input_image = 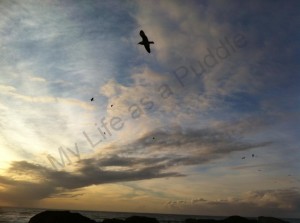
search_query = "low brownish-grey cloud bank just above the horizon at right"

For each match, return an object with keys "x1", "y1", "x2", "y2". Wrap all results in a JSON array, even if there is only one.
[{"x1": 165, "y1": 188, "x2": 300, "y2": 217}]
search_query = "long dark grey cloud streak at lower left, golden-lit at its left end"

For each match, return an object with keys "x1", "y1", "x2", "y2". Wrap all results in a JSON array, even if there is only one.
[{"x1": 0, "y1": 160, "x2": 181, "y2": 205}]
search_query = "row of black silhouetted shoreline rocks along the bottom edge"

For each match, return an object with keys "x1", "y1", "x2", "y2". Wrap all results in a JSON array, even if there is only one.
[{"x1": 28, "y1": 211, "x2": 288, "y2": 223}]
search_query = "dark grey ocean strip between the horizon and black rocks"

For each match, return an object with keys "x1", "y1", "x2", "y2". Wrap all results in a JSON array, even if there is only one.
[{"x1": 0, "y1": 207, "x2": 300, "y2": 223}]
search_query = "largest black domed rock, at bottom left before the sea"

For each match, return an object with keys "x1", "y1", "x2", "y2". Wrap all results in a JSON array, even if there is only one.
[{"x1": 29, "y1": 211, "x2": 96, "y2": 223}]
